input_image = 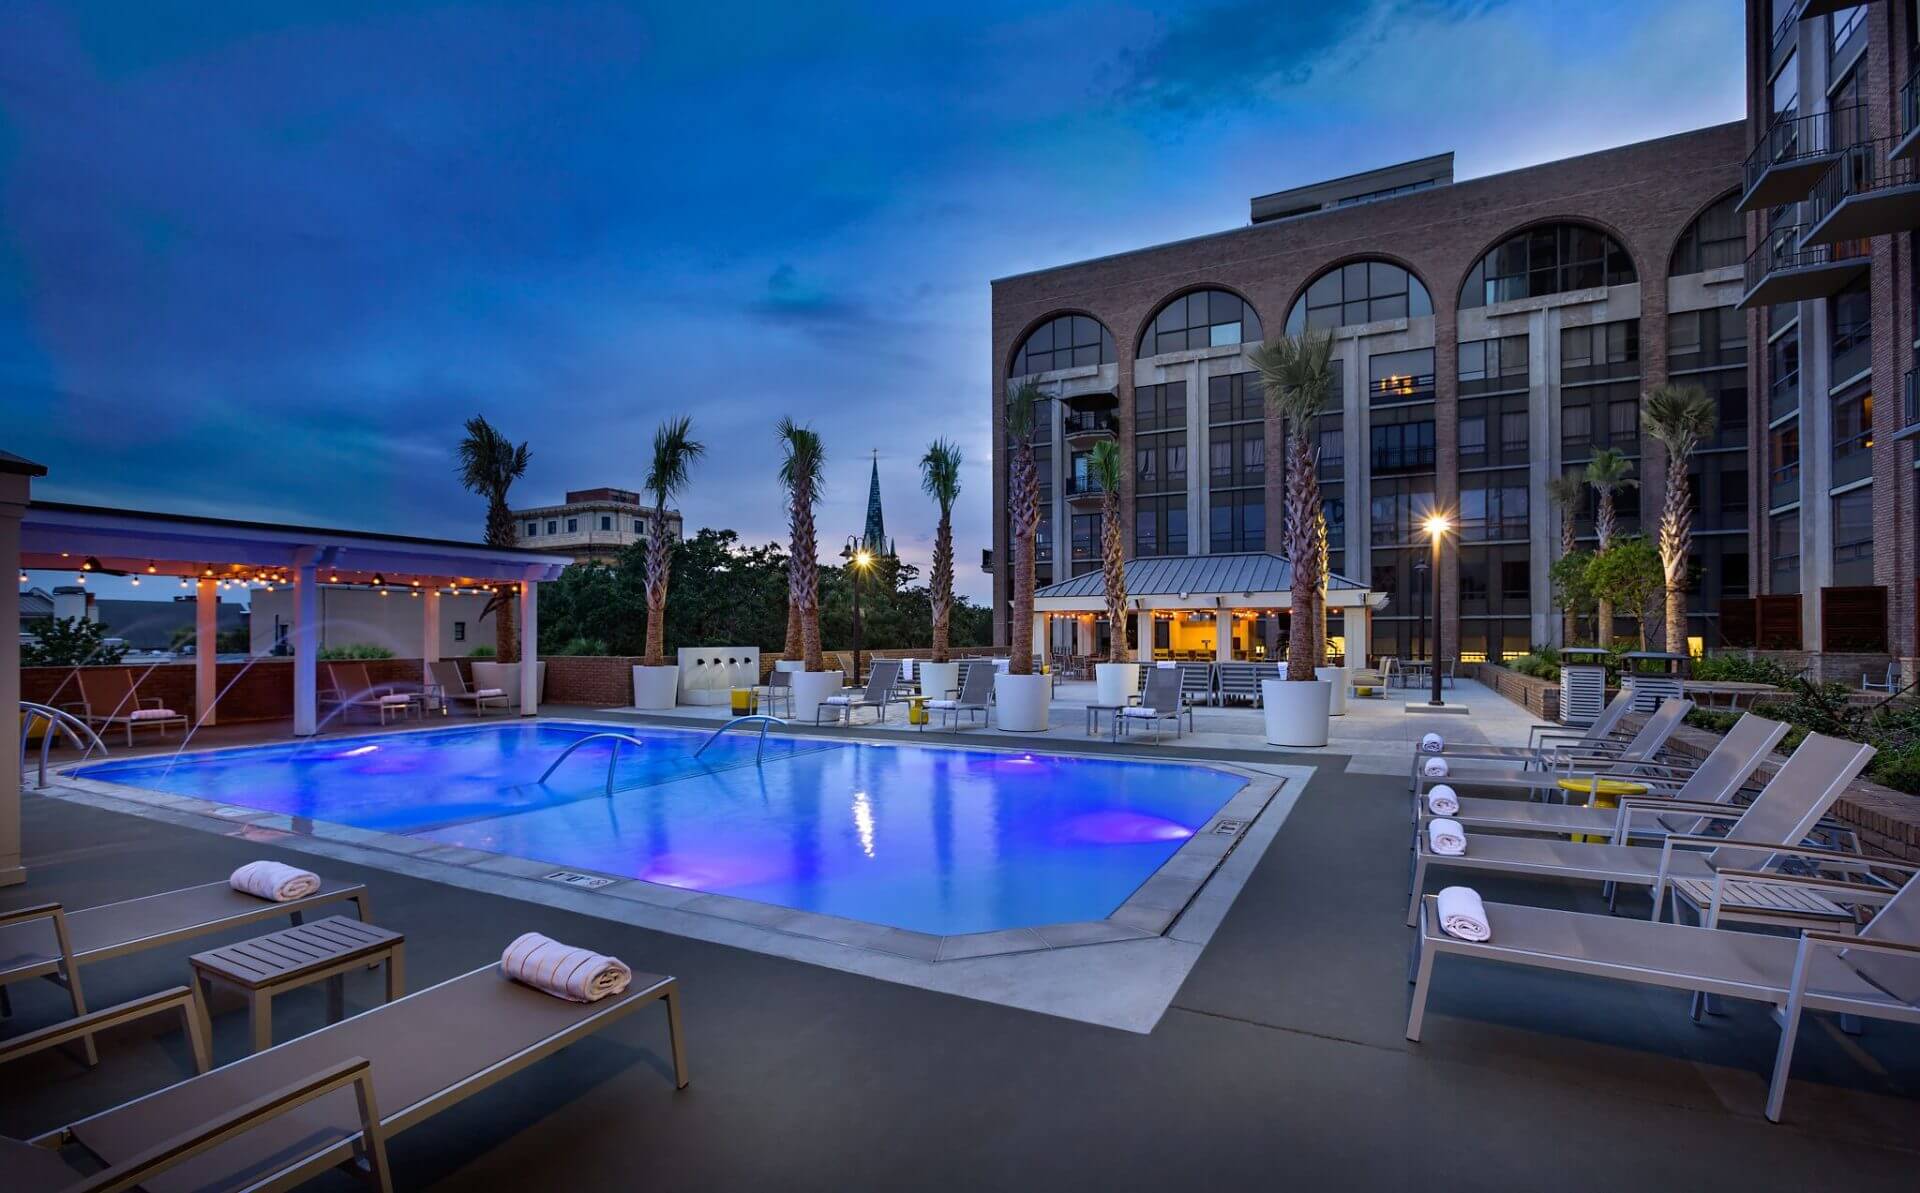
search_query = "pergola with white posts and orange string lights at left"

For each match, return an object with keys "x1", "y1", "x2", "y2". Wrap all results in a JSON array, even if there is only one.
[{"x1": 0, "y1": 451, "x2": 572, "y2": 886}]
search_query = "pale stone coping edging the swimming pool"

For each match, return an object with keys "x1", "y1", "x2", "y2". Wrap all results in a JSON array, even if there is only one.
[{"x1": 60, "y1": 717, "x2": 1288, "y2": 962}]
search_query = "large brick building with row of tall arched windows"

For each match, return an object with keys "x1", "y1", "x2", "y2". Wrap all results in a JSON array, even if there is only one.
[{"x1": 989, "y1": 123, "x2": 1755, "y2": 661}]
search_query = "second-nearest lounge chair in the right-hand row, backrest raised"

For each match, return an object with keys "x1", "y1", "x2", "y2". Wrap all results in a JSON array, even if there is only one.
[{"x1": 1407, "y1": 734, "x2": 1874, "y2": 928}]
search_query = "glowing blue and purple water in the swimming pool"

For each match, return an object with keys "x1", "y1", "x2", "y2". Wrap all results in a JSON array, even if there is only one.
[{"x1": 79, "y1": 720, "x2": 1244, "y2": 936}]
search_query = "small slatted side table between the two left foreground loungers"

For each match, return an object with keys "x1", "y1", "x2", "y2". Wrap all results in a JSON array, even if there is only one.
[{"x1": 188, "y1": 916, "x2": 407, "y2": 1053}]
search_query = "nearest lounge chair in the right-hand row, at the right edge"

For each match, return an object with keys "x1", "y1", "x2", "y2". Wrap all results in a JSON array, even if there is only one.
[{"x1": 1407, "y1": 866, "x2": 1920, "y2": 1122}]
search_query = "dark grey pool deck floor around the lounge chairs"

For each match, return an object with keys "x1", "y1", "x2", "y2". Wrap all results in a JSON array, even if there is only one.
[{"x1": 11, "y1": 684, "x2": 1920, "y2": 1191}]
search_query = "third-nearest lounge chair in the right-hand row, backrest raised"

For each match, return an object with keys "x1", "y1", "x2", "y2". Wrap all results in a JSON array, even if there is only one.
[{"x1": 1413, "y1": 713, "x2": 1788, "y2": 843}]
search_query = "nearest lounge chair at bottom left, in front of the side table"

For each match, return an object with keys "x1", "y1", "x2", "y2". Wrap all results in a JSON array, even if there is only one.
[{"x1": 11, "y1": 964, "x2": 687, "y2": 1193}]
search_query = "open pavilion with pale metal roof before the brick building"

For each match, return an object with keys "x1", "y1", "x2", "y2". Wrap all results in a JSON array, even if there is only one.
[{"x1": 1033, "y1": 551, "x2": 1386, "y2": 663}]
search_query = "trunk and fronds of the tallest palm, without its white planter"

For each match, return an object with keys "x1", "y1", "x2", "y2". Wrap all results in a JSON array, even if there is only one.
[{"x1": 1248, "y1": 332, "x2": 1332, "y2": 680}]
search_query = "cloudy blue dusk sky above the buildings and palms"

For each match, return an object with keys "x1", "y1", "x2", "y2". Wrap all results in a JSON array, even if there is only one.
[{"x1": 0, "y1": 0, "x2": 1741, "y2": 596}]
